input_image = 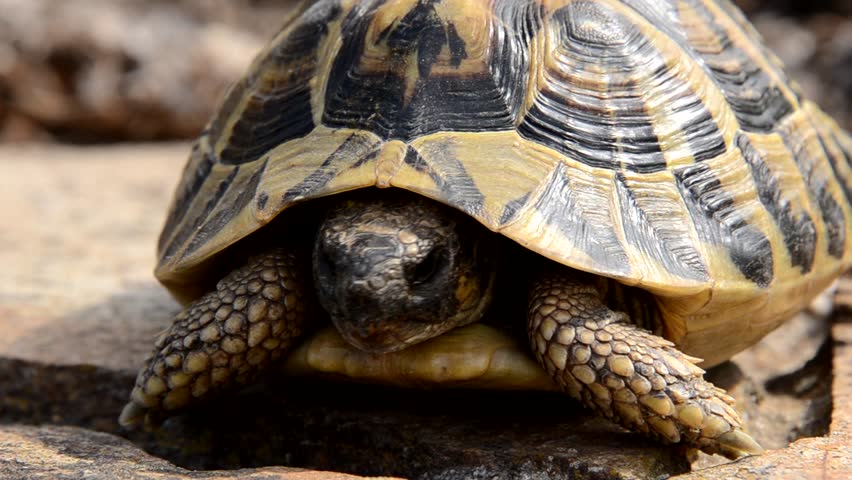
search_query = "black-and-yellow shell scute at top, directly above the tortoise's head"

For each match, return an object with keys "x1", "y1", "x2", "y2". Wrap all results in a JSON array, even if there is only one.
[{"x1": 322, "y1": 1, "x2": 528, "y2": 141}]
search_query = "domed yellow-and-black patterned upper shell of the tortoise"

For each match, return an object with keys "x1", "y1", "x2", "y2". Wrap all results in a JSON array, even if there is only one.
[{"x1": 156, "y1": 0, "x2": 852, "y2": 365}]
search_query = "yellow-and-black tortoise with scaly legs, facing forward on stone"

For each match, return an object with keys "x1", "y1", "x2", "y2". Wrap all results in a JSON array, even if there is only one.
[{"x1": 120, "y1": 0, "x2": 852, "y2": 458}]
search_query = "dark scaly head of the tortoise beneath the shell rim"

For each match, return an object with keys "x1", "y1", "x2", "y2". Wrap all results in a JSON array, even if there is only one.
[{"x1": 313, "y1": 192, "x2": 495, "y2": 353}]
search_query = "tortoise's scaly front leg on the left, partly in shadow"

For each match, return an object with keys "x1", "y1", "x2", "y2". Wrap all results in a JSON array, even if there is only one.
[{"x1": 119, "y1": 249, "x2": 310, "y2": 426}]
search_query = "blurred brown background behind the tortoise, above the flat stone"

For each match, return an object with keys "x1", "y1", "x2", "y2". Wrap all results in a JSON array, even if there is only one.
[{"x1": 0, "y1": 0, "x2": 852, "y2": 144}]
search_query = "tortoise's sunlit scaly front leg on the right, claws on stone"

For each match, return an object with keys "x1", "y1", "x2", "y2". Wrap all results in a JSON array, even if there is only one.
[{"x1": 528, "y1": 272, "x2": 763, "y2": 458}]
